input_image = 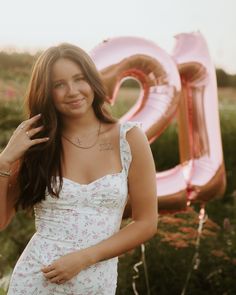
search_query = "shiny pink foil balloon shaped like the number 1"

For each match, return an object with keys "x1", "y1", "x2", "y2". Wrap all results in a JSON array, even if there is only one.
[{"x1": 173, "y1": 32, "x2": 226, "y2": 201}]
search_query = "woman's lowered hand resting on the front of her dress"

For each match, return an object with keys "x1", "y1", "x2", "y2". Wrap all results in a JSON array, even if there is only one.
[{"x1": 41, "y1": 252, "x2": 86, "y2": 284}]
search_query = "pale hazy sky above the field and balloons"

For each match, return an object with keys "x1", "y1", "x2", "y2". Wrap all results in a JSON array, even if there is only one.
[{"x1": 0, "y1": 0, "x2": 236, "y2": 74}]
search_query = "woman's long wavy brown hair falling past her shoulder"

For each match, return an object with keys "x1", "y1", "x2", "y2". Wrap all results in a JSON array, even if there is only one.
[{"x1": 16, "y1": 43, "x2": 116, "y2": 211}]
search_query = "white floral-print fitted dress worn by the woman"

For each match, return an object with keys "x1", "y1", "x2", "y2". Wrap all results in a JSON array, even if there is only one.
[{"x1": 7, "y1": 122, "x2": 140, "y2": 295}]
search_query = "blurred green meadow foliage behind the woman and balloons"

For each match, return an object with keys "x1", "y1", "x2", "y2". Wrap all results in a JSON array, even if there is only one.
[{"x1": 0, "y1": 52, "x2": 236, "y2": 295}]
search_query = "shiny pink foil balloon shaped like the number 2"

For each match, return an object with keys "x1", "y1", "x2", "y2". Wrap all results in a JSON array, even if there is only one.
[{"x1": 91, "y1": 37, "x2": 187, "y2": 211}]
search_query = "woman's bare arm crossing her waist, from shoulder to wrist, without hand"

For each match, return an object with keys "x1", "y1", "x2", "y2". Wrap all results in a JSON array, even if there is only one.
[{"x1": 81, "y1": 128, "x2": 158, "y2": 263}]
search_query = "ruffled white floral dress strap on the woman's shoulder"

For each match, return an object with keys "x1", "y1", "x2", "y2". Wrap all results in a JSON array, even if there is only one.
[{"x1": 120, "y1": 121, "x2": 142, "y2": 175}]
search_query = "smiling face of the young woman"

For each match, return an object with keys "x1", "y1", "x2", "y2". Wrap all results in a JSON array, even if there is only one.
[{"x1": 51, "y1": 58, "x2": 94, "y2": 117}]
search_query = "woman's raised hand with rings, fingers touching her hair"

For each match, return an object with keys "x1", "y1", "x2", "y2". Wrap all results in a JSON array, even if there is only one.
[{"x1": 1, "y1": 114, "x2": 49, "y2": 165}]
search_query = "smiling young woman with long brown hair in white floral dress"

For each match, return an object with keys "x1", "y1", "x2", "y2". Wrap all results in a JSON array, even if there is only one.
[{"x1": 0, "y1": 44, "x2": 157, "y2": 295}]
